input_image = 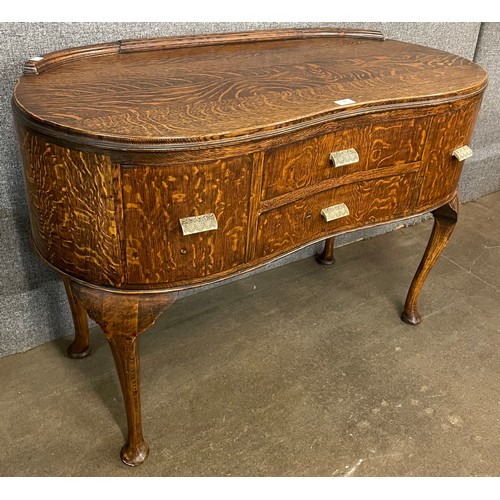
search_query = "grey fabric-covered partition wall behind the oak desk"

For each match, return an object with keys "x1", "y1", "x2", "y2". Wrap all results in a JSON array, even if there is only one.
[{"x1": 0, "y1": 23, "x2": 500, "y2": 356}]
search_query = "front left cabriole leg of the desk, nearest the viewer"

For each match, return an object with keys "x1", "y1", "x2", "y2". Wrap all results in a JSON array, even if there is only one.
[{"x1": 71, "y1": 282, "x2": 176, "y2": 466}]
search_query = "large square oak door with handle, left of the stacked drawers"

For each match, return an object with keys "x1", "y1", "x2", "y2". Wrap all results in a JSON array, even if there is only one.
[{"x1": 122, "y1": 156, "x2": 252, "y2": 284}]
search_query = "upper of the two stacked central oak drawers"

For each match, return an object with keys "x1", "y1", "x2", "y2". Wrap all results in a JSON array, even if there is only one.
[{"x1": 262, "y1": 117, "x2": 428, "y2": 200}]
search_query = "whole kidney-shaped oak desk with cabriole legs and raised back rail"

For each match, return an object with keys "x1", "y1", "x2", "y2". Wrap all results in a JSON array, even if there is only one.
[{"x1": 13, "y1": 29, "x2": 487, "y2": 465}]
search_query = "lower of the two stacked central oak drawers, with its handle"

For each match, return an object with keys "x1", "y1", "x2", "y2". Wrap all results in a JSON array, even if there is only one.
[{"x1": 256, "y1": 172, "x2": 417, "y2": 258}]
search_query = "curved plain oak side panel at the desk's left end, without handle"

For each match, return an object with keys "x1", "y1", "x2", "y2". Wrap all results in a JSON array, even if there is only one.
[{"x1": 19, "y1": 130, "x2": 123, "y2": 286}]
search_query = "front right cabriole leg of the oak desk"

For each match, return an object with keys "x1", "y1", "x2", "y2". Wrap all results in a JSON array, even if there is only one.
[{"x1": 401, "y1": 196, "x2": 458, "y2": 325}]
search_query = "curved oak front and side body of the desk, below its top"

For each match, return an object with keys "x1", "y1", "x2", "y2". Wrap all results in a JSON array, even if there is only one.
[{"x1": 18, "y1": 93, "x2": 481, "y2": 290}]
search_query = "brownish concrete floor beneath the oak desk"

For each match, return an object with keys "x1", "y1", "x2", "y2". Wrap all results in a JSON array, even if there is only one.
[{"x1": 0, "y1": 192, "x2": 500, "y2": 476}]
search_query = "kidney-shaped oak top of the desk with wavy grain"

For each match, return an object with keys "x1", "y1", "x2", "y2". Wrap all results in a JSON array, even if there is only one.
[{"x1": 14, "y1": 30, "x2": 486, "y2": 147}]
